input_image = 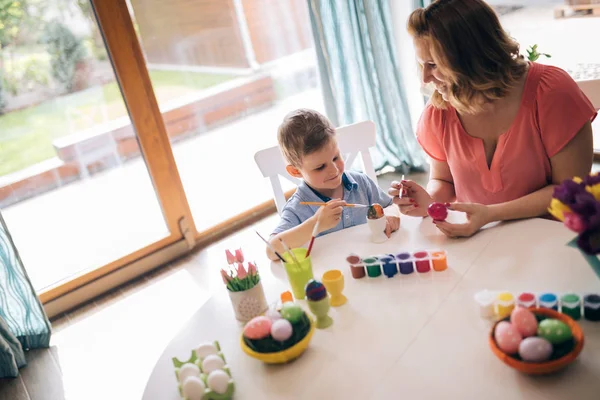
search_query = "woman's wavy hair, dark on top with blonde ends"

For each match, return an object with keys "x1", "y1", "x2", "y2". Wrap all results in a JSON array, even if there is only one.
[{"x1": 407, "y1": 0, "x2": 527, "y2": 113}]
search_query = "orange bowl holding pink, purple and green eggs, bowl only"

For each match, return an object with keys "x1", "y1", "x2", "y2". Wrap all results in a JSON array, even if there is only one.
[{"x1": 489, "y1": 307, "x2": 583, "y2": 375}]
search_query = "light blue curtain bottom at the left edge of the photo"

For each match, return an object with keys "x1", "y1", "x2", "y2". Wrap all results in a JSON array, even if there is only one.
[{"x1": 0, "y1": 214, "x2": 50, "y2": 378}]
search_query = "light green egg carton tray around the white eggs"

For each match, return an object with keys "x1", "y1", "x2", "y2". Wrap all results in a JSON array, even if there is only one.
[{"x1": 172, "y1": 341, "x2": 235, "y2": 400}]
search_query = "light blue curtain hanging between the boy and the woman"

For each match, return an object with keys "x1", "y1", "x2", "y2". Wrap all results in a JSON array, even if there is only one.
[{"x1": 308, "y1": 0, "x2": 425, "y2": 172}]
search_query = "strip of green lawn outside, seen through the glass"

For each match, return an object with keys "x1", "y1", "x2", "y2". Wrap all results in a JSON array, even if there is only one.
[{"x1": 0, "y1": 71, "x2": 233, "y2": 176}]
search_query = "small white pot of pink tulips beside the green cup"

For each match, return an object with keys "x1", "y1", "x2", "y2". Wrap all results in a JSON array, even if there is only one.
[{"x1": 221, "y1": 249, "x2": 268, "y2": 322}]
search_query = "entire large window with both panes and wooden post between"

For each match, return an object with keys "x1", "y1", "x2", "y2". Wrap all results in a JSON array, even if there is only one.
[{"x1": 0, "y1": 0, "x2": 324, "y2": 310}]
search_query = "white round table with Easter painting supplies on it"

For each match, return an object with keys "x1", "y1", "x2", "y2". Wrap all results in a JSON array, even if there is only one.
[{"x1": 143, "y1": 216, "x2": 600, "y2": 400}]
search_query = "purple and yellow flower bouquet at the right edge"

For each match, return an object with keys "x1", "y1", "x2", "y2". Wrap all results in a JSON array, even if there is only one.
[{"x1": 548, "y1": 173, "x2": 600, "y2": 277}]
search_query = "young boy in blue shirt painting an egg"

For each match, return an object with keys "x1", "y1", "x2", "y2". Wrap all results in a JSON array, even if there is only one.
[{"x1": 267, "y1": 109, "x2": 400, "y2": 260}]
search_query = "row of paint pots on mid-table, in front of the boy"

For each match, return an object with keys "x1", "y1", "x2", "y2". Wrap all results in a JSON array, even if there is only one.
[{"x1": 346, "y1": 250, "x2": 448, "y2": 279}]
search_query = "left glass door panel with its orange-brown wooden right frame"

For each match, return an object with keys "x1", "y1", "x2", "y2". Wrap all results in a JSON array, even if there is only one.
[{"x1": 0, "y1": 0, "x2": 195, "y2": 308}]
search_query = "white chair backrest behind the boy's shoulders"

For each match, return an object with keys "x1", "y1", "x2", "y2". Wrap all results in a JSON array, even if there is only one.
[{"x1": 254, "y1": 121, "x2": 377, "y2": 214}]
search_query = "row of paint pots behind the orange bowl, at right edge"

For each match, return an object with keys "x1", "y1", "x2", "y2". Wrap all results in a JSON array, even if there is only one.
[{"x1": 474, "y1": 290, "x2": 600, "y2": 321}]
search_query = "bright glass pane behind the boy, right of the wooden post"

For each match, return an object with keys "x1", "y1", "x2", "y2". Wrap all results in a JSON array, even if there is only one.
[{"x1": 123, "y1": 0, "x2": 324, "y2": 236}]
